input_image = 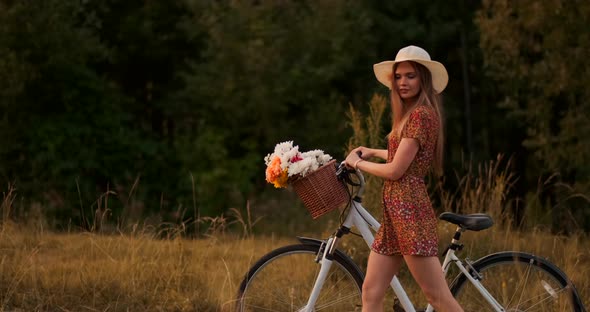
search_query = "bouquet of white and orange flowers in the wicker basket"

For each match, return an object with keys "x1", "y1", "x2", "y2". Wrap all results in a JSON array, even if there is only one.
[{"x1": 264, "y1": 141, "x2": 332, "y2": 188}]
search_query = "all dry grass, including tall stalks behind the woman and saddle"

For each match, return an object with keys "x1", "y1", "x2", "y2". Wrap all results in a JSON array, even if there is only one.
[{"x1": 0, "y1": 96, "x2": 590, "y2": 311}]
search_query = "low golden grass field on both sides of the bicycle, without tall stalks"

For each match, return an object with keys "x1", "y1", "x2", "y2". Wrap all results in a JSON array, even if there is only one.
[{"x1": 0, "y1": 218, "x2": 590, "y2": 311}]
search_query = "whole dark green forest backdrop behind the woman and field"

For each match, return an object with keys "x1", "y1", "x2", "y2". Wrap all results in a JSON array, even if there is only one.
[{"x1": 0, "y1": 0, "x2": 590, "y2": 232}]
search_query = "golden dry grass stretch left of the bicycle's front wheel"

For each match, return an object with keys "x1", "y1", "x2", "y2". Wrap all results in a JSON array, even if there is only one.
[{"x1": 0, "y1": 222, "x2": 290, "y2": 311}]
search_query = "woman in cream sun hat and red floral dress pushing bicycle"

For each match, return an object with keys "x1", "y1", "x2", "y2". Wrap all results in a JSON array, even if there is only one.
[{"x1": 346, "y1": 46, "x2": 463, "y2": 312}]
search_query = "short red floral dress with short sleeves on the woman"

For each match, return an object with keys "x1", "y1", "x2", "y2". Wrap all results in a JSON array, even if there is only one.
[{"x1": 371, "y1": 105, "x2": 440, "y2": 256}]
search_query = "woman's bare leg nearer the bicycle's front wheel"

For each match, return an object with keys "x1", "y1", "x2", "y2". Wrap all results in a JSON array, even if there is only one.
[{"x1": 363, "y1": 251, "x2": 403, "y2": 312}]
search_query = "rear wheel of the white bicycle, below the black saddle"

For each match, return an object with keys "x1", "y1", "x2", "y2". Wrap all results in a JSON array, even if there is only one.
[{"x1": 450, "y1": 251, "x2": 584, "y2": 312}]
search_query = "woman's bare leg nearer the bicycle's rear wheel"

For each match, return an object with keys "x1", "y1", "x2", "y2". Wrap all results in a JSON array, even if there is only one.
[{"x1": 404, "y1": 256, "x2": 463, "y2": 312}]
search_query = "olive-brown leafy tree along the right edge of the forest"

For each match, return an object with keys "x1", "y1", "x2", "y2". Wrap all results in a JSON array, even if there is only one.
[{"x1": 477, "y1": 0, "x2": 590, "y2": 230}]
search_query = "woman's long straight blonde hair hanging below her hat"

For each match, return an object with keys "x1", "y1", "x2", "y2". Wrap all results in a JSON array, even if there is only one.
[{"x1": 388, "y1": 61, "x2": 444, "y2": 176}]
